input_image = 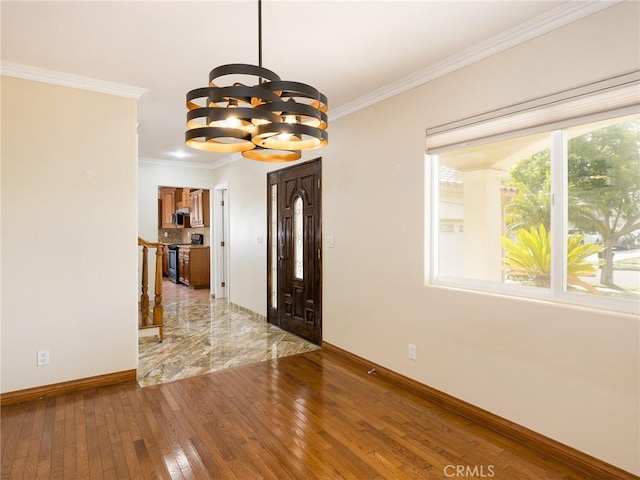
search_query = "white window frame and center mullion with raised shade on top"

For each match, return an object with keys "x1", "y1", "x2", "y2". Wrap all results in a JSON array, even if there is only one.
[{"x1": 425, "y1": 72, "x2": 640, "y2": 314}]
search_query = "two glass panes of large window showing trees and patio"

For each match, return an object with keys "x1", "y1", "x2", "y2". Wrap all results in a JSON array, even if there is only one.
[{"x1": 436, "y1": 115, "x2": 640, "y2": 308}]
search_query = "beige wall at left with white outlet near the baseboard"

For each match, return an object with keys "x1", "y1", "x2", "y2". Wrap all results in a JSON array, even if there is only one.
[{"x1": 1, "y1": 77, "x2": 137, "y2": 392}]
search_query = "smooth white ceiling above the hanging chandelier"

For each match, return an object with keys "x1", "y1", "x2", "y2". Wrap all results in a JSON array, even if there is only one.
[{"x1": 0, "y1": 0, "x2": 615, "y2": 169}]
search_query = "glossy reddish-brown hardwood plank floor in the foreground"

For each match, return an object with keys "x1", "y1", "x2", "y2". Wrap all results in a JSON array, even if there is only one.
[{"x1": 1, "y1": 350, "x2": 600, "y2": 480}]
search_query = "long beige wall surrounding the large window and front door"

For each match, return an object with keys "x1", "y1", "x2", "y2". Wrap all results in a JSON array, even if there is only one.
[{"x1": 214, "y1": 2, "x2": 640, "y2": 474}]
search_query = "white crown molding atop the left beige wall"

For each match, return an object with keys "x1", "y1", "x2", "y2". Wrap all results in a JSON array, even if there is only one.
[{"x1": 0, "y1": 60, "x2": 149, "y2": 100}]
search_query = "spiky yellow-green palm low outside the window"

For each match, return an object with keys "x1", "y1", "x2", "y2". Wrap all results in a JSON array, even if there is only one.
[{"x1": 502, "y1": 223, "x2": 603, "y2": 292}]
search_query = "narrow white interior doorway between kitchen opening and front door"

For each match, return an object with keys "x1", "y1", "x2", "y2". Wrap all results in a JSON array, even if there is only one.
[{"x1": 211, "y1": 183, "x2": 230, "y2": 298}]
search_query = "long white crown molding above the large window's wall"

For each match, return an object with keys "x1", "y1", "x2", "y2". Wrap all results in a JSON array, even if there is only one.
[{"x1": 329, "y1": 0, "x2": 623, "y2": 120}]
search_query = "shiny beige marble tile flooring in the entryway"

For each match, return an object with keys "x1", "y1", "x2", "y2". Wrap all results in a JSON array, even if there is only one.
[{"x1": 138, "y1": 281, "x2": 320, "y2": 387}]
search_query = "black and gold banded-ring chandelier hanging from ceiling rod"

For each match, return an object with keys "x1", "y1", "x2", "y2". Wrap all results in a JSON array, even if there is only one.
[{"x1": 185, "y1": 0, "x2": 329, "y2": 162}]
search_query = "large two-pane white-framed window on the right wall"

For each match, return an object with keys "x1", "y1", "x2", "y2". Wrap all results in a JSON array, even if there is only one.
[{"x1": 427, "y1": 73, "x2": 640, "y2": 312}]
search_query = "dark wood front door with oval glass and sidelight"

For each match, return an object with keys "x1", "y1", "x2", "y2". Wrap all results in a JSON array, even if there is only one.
[{"x1": 267, "y1": 159, "x2": 322, "y2": 344}]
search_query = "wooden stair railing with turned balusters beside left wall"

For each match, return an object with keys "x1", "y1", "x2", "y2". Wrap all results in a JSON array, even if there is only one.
[{"x1": 138, "y1": 237, "x2": 164, "y2": 342}]
